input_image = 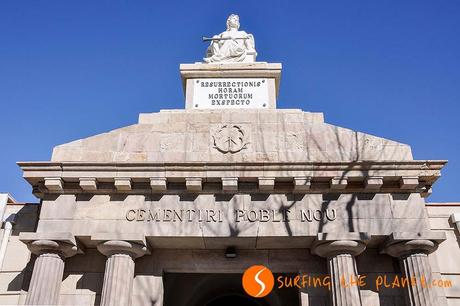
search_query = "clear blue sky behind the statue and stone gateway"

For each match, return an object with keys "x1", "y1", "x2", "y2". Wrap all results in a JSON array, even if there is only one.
[{"x1": 0, "y1": 0, "x2": 460, "y2": 202}]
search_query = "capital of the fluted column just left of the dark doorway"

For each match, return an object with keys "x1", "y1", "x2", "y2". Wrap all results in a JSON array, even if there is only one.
[{"x1": 91, "y1": 233, "x2": 150, "y2": 259}]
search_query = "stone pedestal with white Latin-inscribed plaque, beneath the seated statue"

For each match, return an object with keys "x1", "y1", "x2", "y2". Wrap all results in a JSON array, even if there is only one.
[{"x1": 180, "y1": 62, "x2": 281, "y2": 109}]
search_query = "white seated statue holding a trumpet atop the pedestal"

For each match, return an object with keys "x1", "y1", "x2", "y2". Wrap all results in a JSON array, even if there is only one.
[{"x1": 203, "y1": 14, "x2": 257, "y2": 63}]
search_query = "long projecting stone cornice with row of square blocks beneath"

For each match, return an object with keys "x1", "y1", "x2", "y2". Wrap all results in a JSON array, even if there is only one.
[{"x1": 18, "y1": 160, "x2": 447, "y2": 197}]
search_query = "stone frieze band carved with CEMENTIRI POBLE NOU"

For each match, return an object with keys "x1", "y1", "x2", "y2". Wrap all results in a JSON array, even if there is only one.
[{"x1": 27, "y1": 193, "x2": 438, "y2": 252}]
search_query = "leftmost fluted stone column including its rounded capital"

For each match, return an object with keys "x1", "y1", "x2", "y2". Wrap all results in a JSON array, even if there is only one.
[{"x1": 25, "y1": 239, "x2": 77, "y2": 305}]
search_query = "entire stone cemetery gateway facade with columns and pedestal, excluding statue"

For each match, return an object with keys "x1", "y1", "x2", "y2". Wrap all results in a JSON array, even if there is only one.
[{"x1": 0, "y1": 44, "x2": 460, "y2": 306}]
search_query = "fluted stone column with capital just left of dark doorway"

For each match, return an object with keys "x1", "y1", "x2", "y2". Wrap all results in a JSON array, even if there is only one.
[{"x1": 97, "y1": 240, "x2": 147, "y2": 306}]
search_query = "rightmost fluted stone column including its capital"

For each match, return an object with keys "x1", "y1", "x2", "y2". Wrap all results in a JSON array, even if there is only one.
[{"x1": 381, "y1": 232, "x2": 445, "y2": 306}]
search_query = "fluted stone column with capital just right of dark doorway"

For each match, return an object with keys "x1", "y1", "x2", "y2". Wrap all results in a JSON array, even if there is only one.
[{"x1": 312, "y1": 233, "x2": 368, "y2": 306}]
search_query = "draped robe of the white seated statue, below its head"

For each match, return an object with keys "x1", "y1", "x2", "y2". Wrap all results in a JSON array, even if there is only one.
[{"x1": 205, "y1": 31, "x2": 255, "y2": 62}]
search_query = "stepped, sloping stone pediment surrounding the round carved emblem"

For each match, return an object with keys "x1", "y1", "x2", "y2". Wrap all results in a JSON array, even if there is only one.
[{"x1": 52, "y1": 109, "x2": 412, "y2": 162}]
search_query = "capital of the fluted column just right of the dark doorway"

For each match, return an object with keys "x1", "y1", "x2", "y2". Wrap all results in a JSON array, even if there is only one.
[{"x1": 311, "y1": 232, "x2": 370, "y2": 257}]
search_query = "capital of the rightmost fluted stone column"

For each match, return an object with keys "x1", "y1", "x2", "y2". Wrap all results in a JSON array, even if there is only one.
[{"x1": 380, "y1": 232, "x2": 446, "y2": 258}]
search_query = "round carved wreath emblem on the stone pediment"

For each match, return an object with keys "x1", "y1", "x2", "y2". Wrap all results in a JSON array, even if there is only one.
[{"x1": 212, "y1": 124, "x2": 249, "y2": 154}]
